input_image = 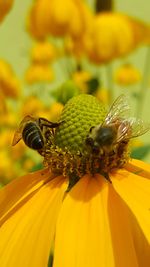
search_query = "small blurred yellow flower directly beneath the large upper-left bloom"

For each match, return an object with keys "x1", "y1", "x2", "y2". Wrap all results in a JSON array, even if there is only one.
[{"x1": 31, "y1": 41, "x2": 56, "y2": 64}]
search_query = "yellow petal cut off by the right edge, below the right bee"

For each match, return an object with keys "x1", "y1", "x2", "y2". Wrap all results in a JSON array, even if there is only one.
[{"x1": 111, "y1": 170, "x2": 150, "y2": 245}]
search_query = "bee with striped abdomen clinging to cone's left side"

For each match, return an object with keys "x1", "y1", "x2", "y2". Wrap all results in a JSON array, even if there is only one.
[{"x1": 12, "y1": 115, "x2": 61, "y2": 151}]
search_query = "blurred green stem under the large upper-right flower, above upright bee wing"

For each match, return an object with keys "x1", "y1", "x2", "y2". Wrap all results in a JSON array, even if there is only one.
[{"x1": 106, "y1": 63, "x2": 114, "y2": 106}]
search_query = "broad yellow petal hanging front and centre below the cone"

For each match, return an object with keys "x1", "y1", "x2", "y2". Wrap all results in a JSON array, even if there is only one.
[{"x1": 53, "y1": 175, "x2": 147, "y2": 267}]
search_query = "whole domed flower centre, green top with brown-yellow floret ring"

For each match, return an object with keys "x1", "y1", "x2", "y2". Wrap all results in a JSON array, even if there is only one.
[{"x1": 41, "y1": 94, "x2": 129, "y2": 189}]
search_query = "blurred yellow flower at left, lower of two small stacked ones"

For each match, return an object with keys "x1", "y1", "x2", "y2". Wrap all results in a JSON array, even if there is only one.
[{"x1": 25, "y1": 64, "x2": 54, "y2": 84}]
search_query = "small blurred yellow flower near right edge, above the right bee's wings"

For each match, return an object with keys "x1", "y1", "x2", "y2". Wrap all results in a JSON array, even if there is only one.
[{"x1": 115, "y1": 64, "x2": 141, "y2": 85}]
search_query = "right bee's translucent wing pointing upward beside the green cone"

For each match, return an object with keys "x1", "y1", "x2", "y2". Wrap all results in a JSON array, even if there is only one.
[{"x1": 104, "y1": 94, "x2": 130, "y2": 124}]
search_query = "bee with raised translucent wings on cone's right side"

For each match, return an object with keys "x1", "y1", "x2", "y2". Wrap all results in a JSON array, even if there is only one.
[{"x1": 86, "y1": 95, "x2": 150, "y2": 154}]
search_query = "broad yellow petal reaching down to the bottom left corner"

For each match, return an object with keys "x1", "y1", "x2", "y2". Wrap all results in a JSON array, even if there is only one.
[{"x1": 0, "y1": 176, "x2": 66, "y2": 267}]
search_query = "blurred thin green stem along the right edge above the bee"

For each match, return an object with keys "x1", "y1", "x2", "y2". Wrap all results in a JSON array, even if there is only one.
[{"x1": 137, "y1": 47, "x2": 150, "y2": 117}]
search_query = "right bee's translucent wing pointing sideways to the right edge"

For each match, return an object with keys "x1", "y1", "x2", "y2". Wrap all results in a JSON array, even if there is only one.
[{"x1": 128, "y1": 117, "x2": 150, "y2": 138}]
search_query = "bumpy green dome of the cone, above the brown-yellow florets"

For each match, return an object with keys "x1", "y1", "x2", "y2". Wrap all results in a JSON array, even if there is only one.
[{"x1": 55, "y1": 94, "x2": 106, "y2": 152}]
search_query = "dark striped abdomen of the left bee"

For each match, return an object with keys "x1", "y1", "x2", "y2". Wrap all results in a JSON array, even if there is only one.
[{"x1": 22, "y1": 122, "x2": 44, "y2": 150}]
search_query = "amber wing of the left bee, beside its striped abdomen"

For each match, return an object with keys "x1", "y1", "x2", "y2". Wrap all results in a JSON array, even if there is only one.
[{"x1": 12, "y1": 115, "x2": 34, "y2": 146}]
